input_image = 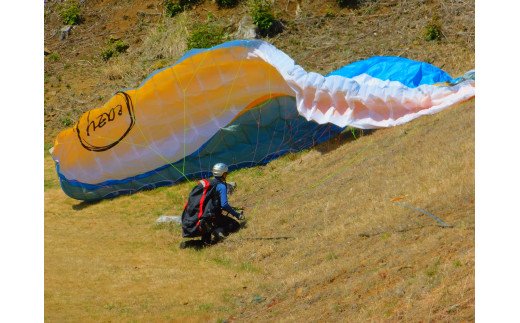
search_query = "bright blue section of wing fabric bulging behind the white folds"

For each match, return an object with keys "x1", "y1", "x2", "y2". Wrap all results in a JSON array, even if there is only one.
[{"x1": 327, "y1": 56, "x2": 453, "y2": 88}]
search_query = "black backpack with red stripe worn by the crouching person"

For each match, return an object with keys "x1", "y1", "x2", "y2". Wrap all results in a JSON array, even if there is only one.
[{"x1": 181, "y1": 179, "x2": 222, "y2": 238}]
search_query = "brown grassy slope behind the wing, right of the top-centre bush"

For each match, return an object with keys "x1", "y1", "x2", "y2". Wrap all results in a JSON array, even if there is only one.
[{"x1": 272, "y1": 0, "x2": 475, "y2": 75}]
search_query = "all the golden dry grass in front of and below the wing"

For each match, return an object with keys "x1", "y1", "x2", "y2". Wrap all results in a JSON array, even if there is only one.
[{"x1": 45, "y1": 101, "x2": 475, "y2": 321}]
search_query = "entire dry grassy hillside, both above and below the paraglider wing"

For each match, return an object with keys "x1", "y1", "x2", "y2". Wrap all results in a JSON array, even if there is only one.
[{"x1": 44, "y1": 0, "x2": 475, "y2": 322}]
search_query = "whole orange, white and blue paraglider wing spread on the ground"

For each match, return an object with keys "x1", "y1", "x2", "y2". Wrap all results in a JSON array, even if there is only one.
[{"x1": 52, "y1": 40, "x2": 474, "y2": 200}]
